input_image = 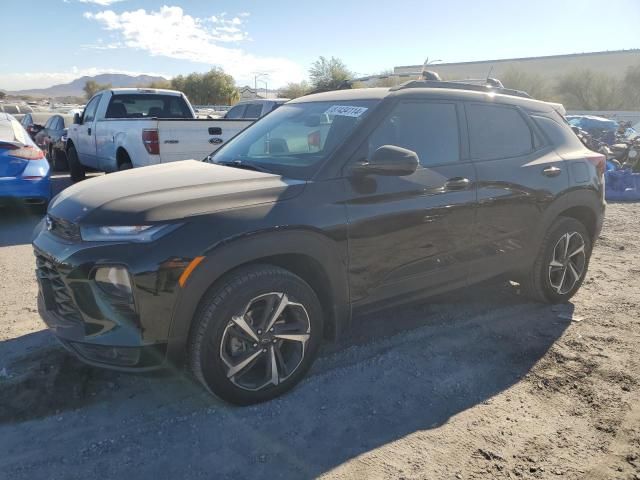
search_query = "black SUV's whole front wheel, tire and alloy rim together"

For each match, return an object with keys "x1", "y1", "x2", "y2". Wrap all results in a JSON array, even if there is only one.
[{"x1": 189, "y1": 265, "x2": 322, "y2": 405}]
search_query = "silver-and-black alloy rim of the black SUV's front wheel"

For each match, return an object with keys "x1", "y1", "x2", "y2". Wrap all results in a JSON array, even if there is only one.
[{"x1": 220, "y1": 292, "x2": 311, "y2": 391}]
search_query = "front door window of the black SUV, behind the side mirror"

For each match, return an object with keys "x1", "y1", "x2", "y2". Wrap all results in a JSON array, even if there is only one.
[{"x1": 368, "y1": 101, "x2": 460, "y2": 167}]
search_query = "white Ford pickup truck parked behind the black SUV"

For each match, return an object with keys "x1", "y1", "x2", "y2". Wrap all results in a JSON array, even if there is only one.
[{"x1": 66, "y1": 88, "x2": 255, "y2": 182}]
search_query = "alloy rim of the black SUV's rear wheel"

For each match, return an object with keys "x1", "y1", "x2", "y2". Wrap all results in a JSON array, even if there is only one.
[{"x1": 549, "y1": 232, "x2": 587, "y2": 295}]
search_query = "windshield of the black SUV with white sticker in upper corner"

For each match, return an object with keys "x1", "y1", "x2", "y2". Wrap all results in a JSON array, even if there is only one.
[{"x1": 209, "y1": 100, "x2": 379, "y2": 179}]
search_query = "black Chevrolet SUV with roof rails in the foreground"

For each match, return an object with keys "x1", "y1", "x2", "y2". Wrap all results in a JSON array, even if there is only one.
[{"x1": 34, "y1": 81, "x2": 605, "y2": 404}]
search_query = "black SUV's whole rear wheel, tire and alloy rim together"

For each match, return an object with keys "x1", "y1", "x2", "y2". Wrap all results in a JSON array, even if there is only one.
[{"x1": 522, "y1": 217, "x2": 592, "y2": 303}]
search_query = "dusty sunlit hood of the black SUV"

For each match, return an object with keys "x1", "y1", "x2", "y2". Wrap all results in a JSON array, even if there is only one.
[{"x1": 49, "y1": 160, "x2": 305, "y2": 225}]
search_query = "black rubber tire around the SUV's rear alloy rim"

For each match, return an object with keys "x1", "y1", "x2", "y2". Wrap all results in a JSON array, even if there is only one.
[{"x1": 521, "y1": 217, "x2": 592, "y2": 304}]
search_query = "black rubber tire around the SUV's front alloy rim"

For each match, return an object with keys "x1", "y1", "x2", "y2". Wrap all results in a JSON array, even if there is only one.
[{"x1": 188, "y1": 265, "x2": 323, "y2": 405}]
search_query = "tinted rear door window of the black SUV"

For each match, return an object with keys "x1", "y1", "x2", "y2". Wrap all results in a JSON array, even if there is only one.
[{"x1": 466, "y1": 103, "x2": 534, "y2": 160}]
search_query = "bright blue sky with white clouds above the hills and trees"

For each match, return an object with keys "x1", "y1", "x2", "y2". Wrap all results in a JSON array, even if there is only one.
[{"x1": 0, "y1": 0, "x2": 640, "y2": 90}]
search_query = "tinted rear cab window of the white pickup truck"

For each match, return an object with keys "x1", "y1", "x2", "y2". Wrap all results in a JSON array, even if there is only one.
[{"x1": 105, "y1": 93, "x2": 193, "y2": 118}]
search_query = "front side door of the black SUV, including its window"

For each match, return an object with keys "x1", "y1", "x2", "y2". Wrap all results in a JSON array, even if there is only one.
[{"x1": 345, "y1": 99, "x2": 476, "y2": 306}]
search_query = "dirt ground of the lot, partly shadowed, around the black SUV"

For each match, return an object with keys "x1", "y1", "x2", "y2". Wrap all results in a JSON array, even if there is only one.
[{"x1": 0, "y1": 177, "x2": 640, "y2": 479}]
